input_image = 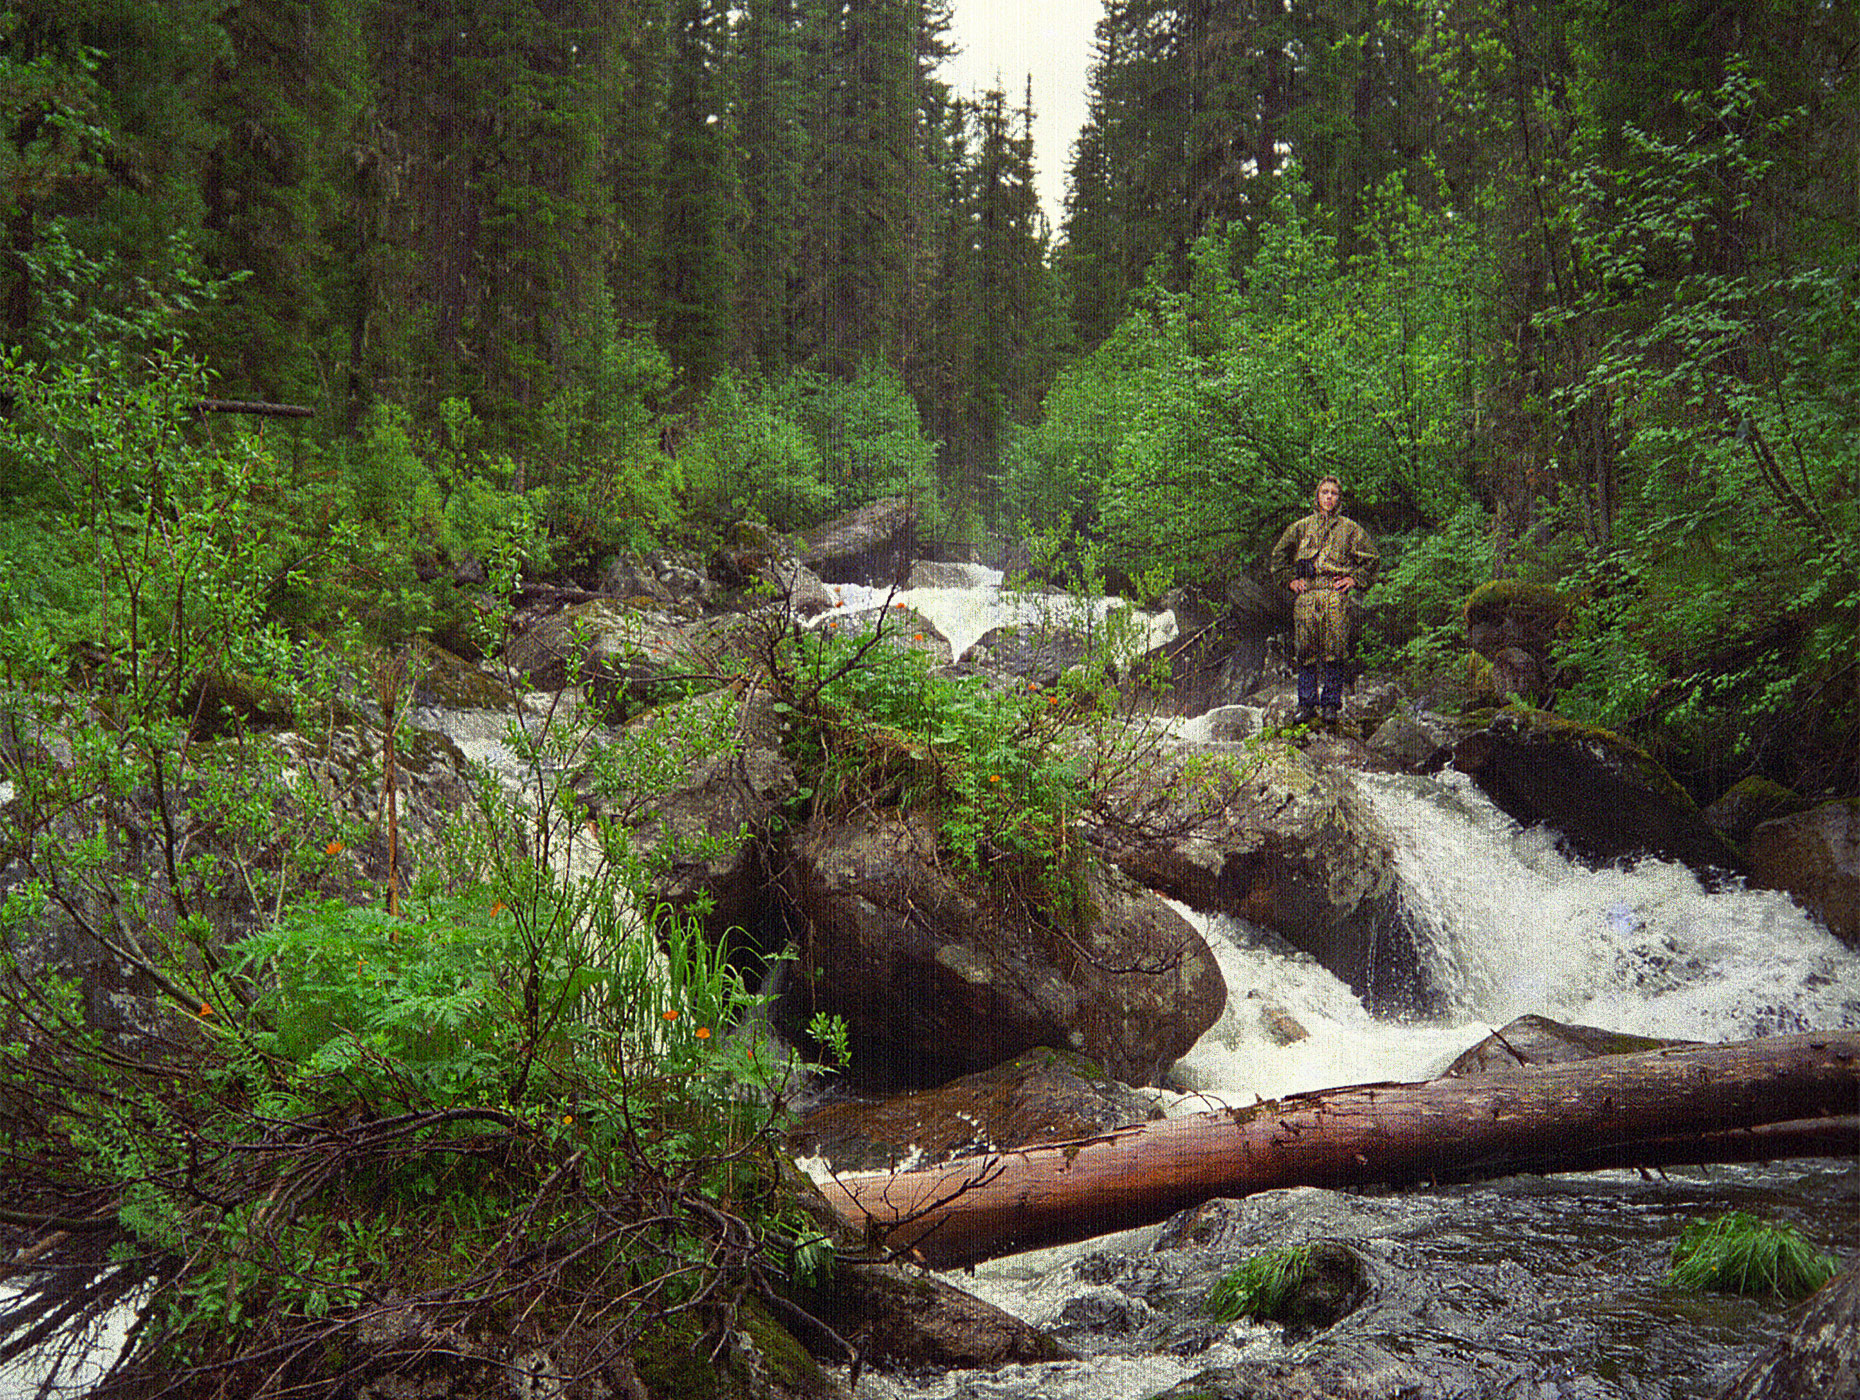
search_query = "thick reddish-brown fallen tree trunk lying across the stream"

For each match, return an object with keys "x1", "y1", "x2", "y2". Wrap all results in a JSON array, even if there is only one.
[{"x1": 822, "y1": 1030, "x2": 1860, "y2": 1266}]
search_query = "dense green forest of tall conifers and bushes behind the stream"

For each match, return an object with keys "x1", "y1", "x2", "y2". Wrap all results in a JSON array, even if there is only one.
[{"x1": 0, "y1": 0, "x2": 1860, "y2": 798}]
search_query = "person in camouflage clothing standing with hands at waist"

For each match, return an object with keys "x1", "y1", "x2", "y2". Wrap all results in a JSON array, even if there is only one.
[{"x1": 1270, "y1": 476, "x2": 1380, "y2": 725}]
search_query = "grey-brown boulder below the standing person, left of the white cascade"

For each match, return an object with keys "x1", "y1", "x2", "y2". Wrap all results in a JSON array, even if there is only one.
[{"x1": 1094, "y1": 744, "x2": 1434, "y2": 1013}]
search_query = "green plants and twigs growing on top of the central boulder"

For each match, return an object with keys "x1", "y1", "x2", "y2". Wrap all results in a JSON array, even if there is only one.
[{"x1": 770, "y1": 535, "x2": 1226, "y2": 926}]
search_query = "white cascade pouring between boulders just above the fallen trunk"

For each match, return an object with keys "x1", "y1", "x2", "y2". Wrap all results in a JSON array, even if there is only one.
[{"x1": 1176, "y1": 773, "x2": 1860, "y2": 1110}]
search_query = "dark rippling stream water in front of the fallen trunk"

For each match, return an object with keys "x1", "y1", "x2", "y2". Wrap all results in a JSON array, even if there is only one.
[{"x1": 861, "y1": 1162, "x2": 1860, "y2": 1400}]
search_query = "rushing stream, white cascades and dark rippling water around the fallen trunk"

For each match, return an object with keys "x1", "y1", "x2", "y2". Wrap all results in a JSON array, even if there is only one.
[{"x1": 822, "y1": 576, "x2": 1860, "y2": 1400}]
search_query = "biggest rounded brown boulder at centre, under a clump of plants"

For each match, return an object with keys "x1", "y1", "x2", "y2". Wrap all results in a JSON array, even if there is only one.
[{"x1": 781, "y1": 809, "x2": 1226, "y2": 1088}]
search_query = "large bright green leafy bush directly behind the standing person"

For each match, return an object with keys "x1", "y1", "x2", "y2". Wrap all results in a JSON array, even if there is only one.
[{"x1": 1034, "y1": 171, "x2": 1486, "y2": 584}]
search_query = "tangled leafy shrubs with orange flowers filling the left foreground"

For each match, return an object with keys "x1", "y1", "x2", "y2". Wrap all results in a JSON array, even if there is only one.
[{"x1": 0, "y1": 336, "x2": 830, "y2": 1391}]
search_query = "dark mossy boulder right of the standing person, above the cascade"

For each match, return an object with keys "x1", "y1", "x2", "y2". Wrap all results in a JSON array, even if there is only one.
[{"x1": 1453, "y1": 708, "x2": 1743, "y2": 874}]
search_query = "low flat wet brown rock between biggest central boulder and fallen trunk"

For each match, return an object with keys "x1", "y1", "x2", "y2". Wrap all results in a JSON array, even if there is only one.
[{"x1": 789, "y1": 1047, "x2": 1163, "y2": 1171}]
